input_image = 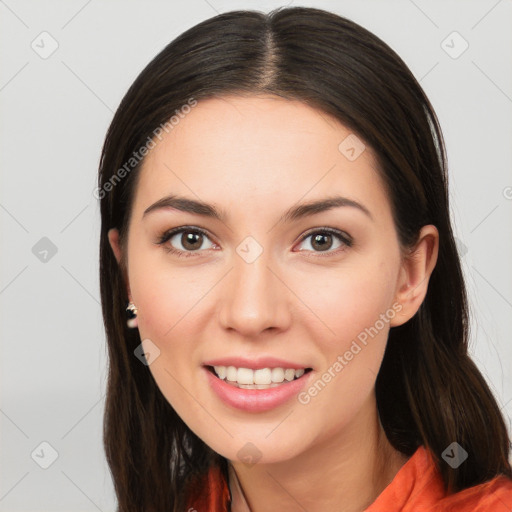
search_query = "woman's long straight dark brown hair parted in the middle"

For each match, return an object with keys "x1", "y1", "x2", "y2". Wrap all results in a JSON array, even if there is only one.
[{"x1": 97, "y1": 7, "x2": 512, "y2": 512}]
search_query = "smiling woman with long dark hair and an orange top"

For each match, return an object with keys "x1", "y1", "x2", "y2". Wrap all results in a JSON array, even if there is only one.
[{"x1": 98, "y1": 8, "x2": 512, "y2": 512}]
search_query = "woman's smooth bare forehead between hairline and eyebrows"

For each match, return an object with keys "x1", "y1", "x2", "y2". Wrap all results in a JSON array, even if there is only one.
[{"x1": 131, "y1": 96, "x2": 388, "y2": 221}]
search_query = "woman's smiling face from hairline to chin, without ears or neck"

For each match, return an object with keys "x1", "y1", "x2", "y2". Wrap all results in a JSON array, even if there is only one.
[{"x1": 111, "y1": 96, "x2": 408, "y2": 462}]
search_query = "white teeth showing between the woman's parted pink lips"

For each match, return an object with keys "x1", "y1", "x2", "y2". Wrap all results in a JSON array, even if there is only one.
[{"x1": 206, "y1": 366, "x2": 312, "y2": 389}]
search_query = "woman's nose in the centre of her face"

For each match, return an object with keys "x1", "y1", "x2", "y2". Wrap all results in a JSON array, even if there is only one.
[{"x1": 219, "y1": 246, "x2": 293, "y2": 338}]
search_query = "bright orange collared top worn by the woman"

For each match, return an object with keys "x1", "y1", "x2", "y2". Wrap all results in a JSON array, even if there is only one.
[{"x1": 186, "y1": 446, "x2": 512, "y2": 512}]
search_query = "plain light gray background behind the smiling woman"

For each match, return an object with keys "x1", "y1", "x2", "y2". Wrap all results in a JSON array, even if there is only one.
[{"x1": 0, "y1": 0, "x2": 512, "y2": 512}]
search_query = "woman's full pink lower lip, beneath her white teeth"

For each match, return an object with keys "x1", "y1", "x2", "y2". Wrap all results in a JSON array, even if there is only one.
[{"x1": 203, "y1": 359, "x2": 313, "y2": 413}]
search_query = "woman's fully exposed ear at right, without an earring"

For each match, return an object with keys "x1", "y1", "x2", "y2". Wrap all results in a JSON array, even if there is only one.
[{"x1": 390, "y1": 224, "x2": 439, "y2": 327}]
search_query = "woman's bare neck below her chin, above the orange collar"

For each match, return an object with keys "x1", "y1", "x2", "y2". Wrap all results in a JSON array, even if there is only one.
[{"x1": 230, "y1": 394, "x2": 407, "y2": 512}]
